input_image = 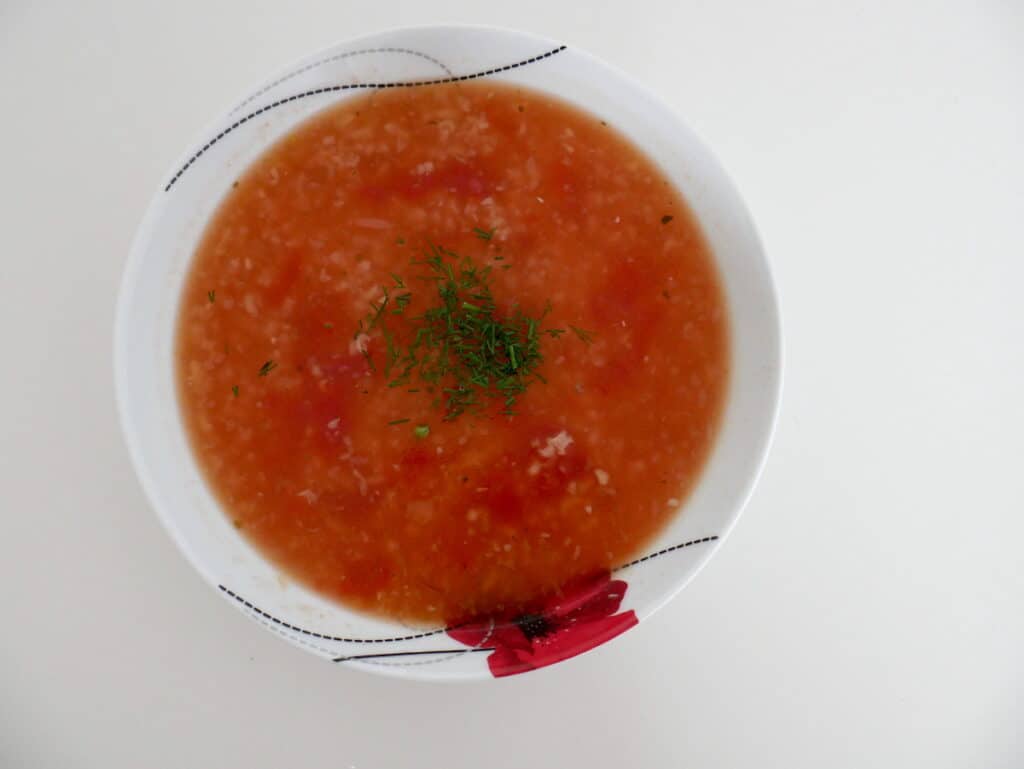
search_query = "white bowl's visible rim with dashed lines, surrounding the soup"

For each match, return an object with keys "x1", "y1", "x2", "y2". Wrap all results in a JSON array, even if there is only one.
[{"x1": 115, "y1": 27, "x2": 781, "y2": 679}]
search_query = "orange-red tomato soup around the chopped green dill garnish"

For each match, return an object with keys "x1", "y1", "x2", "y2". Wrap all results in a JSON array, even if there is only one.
[{"x1": 176, "y1": 81, "x2": 728, "y2": 624}]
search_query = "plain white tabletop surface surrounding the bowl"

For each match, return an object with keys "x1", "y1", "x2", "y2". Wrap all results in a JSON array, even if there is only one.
[{"x1": 0, "y1": 0, "x2": 1024, "y2": 769}]
